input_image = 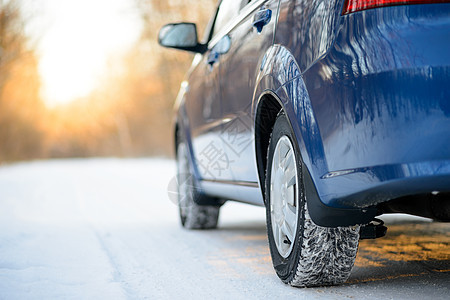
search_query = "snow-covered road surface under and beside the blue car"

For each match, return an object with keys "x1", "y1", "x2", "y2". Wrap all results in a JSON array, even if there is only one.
[{"x1": 0, "y1": 159, "x2": 450, "y2": 299}]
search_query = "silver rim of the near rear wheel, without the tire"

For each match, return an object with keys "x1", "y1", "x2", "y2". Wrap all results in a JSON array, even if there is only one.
[{"x1": 270, "y1": 136, "x2": 299, "y2": 258}]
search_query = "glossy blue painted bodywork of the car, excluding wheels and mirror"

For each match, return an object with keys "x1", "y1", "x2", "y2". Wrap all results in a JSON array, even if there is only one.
[{"x1": 174, "y1": 0, "x2": 450, "y2": 211}]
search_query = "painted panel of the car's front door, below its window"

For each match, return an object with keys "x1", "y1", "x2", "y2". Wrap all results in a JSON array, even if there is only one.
[{"x1": 184, "y1": 5, "x2": 231, "y2": 181}]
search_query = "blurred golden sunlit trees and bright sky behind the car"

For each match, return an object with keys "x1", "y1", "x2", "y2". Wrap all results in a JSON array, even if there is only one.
[{"x1": 0, "y1": 0, "x2": 216, "y2": 162}]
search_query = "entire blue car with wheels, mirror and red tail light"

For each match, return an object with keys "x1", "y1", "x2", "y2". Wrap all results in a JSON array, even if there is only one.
[{"x1": 159, "y1": 0, "x2": 450, "y2": 287}]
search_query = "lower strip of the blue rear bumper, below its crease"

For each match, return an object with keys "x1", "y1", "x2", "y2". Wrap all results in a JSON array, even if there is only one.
[{"x1": 321, "y1": 160, "x2": 450, "y2": 208}]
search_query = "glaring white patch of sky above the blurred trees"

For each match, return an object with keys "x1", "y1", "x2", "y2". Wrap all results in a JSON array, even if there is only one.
[{"x1": 25, "y1": 0, "x2": 142, "y2": 106}]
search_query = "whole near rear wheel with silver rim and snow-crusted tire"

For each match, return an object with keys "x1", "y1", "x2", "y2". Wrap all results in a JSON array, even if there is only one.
[{"x1": 265, "y1": 112, "x2": 359, "y2": 287}]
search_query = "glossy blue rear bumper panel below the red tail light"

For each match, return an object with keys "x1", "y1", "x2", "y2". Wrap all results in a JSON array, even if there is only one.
[{"x1": 303, "y1": 4, "x2": 450, "y2": 209}]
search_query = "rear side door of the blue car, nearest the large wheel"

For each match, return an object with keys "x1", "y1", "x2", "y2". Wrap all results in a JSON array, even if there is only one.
[{"x1": 215, "y1": 0, "x2": 279, "y2": 184}]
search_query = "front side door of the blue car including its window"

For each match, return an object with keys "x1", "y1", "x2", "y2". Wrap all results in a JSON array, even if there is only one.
[{"x1": 186, "y1": 0, "x2": 248, "y2": 182}]
